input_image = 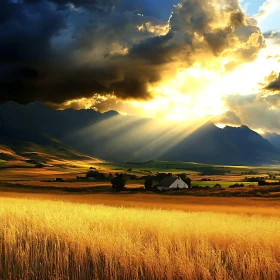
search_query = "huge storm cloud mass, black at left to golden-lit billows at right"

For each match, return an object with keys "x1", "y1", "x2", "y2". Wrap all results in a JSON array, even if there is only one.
[{"x1": 0, "y1": 0, "x2": 265, "y2": 106}]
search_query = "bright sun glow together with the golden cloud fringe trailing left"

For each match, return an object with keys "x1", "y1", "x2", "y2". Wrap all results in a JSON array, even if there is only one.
[{"x1": 57, "y1": 40, "x2": 279, "y2": 126}]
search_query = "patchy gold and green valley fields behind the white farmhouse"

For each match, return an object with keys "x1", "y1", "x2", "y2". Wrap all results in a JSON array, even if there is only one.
[{"x1": 0, "y1": 156, "x2": 280, "y2": 188}]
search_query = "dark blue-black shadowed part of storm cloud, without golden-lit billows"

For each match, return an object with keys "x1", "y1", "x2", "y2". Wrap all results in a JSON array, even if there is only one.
[{"x1": 0, "y1": 0, "x2": 171, "y2": 103}]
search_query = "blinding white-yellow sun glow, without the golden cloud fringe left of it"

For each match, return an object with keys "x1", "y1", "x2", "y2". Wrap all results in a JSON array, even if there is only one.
[{"x1": 127, "y1": 40, "x2": 279, "y2": 122}]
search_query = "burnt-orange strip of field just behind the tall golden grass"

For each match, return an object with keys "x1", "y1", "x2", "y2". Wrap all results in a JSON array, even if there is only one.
[{"x1": 0, "y1": 188, "x2": 280, "y2": 217}]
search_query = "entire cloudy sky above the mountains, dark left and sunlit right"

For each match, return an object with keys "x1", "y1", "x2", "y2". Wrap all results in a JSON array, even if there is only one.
[{"x1": 0, "y1": 0, "x2": 280, "y2": 133}]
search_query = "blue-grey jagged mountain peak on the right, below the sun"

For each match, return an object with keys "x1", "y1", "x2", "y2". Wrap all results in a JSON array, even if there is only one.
[{"x1": 163, "y1": 123, "x2": 280, "y2": 165}]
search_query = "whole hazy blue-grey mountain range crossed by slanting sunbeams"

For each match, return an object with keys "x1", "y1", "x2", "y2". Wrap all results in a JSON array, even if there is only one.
[{"x1": 0, "y1": 102, "x2": 280, "y2": 165}]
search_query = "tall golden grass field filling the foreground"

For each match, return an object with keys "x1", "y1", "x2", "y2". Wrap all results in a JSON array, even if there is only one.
[{"x1": 0, "y1": 198, "x2": 280, "y2": 279}]
